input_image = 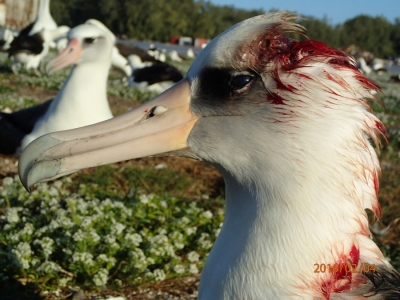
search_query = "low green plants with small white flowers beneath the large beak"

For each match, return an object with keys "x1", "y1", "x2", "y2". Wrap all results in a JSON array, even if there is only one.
[{"x1": 0, "y1": 175, "x2": 223, "y2": 289}]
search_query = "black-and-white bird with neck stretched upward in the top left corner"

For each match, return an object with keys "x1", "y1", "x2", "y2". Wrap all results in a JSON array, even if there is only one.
[{"x1": 8, "y1": 0, "x2": 70, "y2": 76}]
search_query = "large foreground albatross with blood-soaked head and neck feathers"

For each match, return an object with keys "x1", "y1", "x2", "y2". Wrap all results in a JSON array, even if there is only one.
[{"x1": 19, "y1": 12, "x2": 400, "y2": 300}]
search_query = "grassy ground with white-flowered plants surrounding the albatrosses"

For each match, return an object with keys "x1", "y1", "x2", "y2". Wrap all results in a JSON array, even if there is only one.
[{"x1": 0, "y1": 51, "x2": 400, "y2": 299}]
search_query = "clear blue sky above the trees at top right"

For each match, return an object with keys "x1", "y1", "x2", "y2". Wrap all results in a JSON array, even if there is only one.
[{"x1": 210, "y1": 0, "x2": 400, "y2": 25}]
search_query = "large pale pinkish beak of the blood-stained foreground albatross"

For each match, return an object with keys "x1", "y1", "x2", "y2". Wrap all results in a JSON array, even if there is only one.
[{"x1": 18, "y1": 80, "x2": 199, "y2": 190}]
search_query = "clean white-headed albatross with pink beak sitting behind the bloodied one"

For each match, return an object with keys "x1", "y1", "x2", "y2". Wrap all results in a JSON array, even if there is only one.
[{"x1": 0, "y1": 20, "x2": 113, "y2": 154}]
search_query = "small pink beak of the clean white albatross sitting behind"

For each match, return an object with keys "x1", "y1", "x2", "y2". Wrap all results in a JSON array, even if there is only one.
[{"x1": 46, "y1": 38, "x2": 82, "y2": 74}]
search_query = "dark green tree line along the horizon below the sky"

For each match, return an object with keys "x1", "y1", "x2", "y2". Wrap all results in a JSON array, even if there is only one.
[{"x1": 51, "y1": 0, "x2": 400, "y2": 58}]
